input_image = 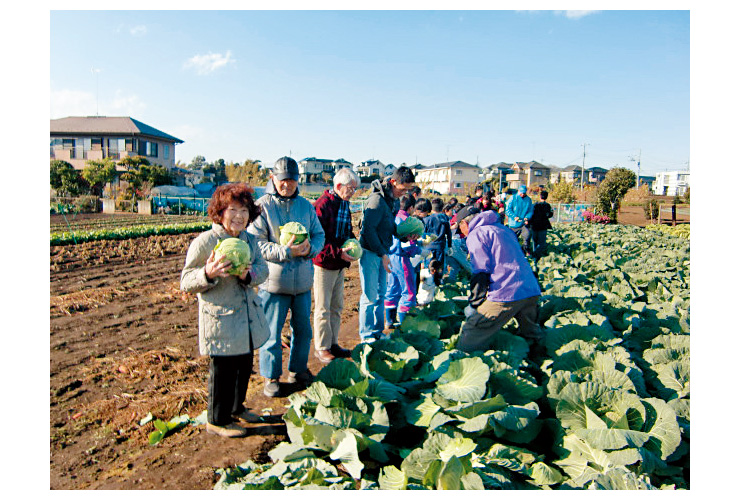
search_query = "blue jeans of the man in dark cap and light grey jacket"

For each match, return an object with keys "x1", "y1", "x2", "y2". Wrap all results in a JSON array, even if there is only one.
[{"x1": 258, "y1": 290, "x2": 311, "y2": 379}]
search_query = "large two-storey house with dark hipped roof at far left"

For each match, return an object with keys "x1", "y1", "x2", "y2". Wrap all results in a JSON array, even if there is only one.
[{"x1": 49, "y1": 116, "x2": 183, "y2": 170}]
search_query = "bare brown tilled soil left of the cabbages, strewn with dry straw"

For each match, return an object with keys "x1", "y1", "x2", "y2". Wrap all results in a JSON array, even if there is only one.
[{"x1": 49, "y1": 207, "x2": 680, "y2": 490}]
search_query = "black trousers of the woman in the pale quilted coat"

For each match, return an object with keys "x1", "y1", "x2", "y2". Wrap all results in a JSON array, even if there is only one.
[{"x1": 207, "y1": 352, "x2": 253, "y2": 426}]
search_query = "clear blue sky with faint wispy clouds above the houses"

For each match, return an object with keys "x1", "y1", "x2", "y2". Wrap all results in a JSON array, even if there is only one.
[{"x1": 50, "y1": 10, "x2": 690, "y2": 174}]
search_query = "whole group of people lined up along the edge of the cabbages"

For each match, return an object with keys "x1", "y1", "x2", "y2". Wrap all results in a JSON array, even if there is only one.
[{"x1": 181, "y1": 157, "x2": 552, "y2": 437}]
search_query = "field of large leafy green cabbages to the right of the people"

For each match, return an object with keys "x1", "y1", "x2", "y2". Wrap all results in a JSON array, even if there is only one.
[{"x1": 215, "y1": 224, "x2": 690, "y2": 490}]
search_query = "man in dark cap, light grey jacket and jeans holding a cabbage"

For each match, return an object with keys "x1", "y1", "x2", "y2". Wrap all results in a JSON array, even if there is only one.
[{"x1": 247, "y1": 156, "x2": 324, "y2": 397}]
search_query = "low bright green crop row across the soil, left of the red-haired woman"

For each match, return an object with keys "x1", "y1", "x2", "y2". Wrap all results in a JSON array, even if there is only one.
[{"x1": 49, "y1": 222, "x2": 211, "y2": 245}]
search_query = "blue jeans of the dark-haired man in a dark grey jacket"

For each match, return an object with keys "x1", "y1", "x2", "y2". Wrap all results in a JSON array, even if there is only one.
[{"x1": 358, "y1": 250, "x2": 386, "y2": 342}]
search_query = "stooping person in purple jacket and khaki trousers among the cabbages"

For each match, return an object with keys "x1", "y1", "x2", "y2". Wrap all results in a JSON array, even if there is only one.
[{"x1": 457, "y1": 209, "x2": 541, "y2": 352}]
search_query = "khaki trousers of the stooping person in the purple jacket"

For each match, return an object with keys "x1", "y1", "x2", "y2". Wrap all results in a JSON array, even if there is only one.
[{"x1": 457, "y1": 296, "x2": 541, "y2": 352}]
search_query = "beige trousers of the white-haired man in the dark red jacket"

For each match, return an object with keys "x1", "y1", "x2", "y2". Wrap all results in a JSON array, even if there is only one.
[{"x1": 314, "y1": 266, "x2": 345, "y2": 349}]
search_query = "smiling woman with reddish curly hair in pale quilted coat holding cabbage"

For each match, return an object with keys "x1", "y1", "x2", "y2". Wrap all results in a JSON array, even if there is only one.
[{"x1": 180, "y1": 183, "x2": 268, "y2": 437}]
